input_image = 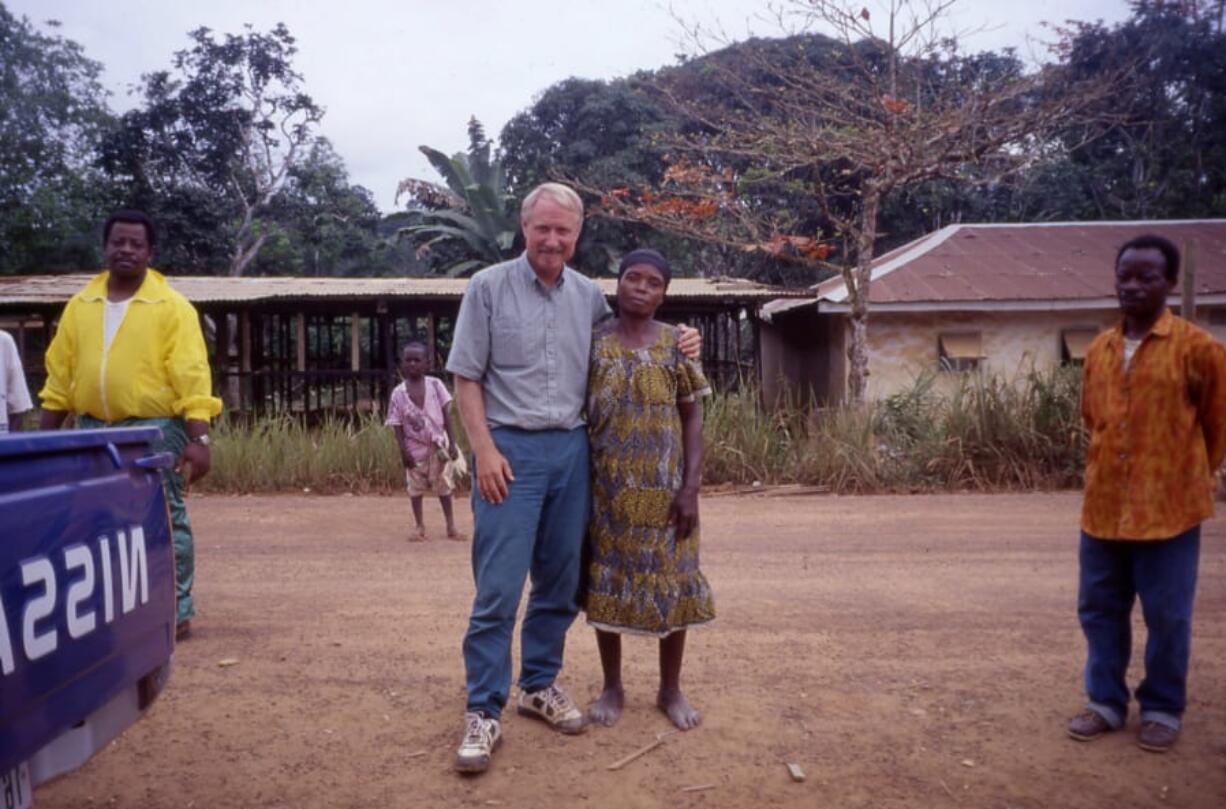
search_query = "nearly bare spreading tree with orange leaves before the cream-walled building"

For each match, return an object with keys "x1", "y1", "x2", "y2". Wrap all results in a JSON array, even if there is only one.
[{"x1": 579, "y1": 0, "x2": 1124, "y2": 402}]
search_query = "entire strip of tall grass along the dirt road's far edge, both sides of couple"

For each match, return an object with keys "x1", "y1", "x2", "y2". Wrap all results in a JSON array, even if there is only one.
[{"x1": 201, "y1": 369, "x2": 1084, "y2": 494}]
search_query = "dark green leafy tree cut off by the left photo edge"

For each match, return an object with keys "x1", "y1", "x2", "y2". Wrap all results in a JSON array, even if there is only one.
[{"x1": 0, "y1": 5, "x2": 112, "y2": 275}]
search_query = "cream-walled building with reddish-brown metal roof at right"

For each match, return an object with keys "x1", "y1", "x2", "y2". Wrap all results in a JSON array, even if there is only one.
[{"x1": 760, "y1": 219, "x2": 1226, "y2": 401}]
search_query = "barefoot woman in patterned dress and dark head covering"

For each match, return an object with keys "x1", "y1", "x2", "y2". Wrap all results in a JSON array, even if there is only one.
[{"x1": 585, "y1": 250, "x2": 715, "y2": 731}]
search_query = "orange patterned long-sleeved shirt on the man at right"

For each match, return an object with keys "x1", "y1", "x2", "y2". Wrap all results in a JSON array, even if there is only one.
[{"x1": 1081, "y1": 311, "x2": 1226, "y2": 539}]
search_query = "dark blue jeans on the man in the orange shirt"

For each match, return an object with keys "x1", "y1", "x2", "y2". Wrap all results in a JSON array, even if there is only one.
[{"x1": 1078, "y1": 526, "x2": 1200, "y2": 729}]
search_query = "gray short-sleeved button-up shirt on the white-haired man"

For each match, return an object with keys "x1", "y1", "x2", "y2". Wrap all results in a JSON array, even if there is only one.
[{"x1": 447, "y1": 255, "x2": 612, "y2": 430}]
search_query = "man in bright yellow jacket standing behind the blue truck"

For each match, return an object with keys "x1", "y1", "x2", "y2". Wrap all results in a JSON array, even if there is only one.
[{"x1": 40, "y1": 211, "x2": 222, "y2": 639}]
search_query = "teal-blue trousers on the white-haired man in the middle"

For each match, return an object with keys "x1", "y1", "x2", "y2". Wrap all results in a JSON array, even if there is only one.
[{"x1": 463, "y1": 428, "x2": 591, "y2": 718}]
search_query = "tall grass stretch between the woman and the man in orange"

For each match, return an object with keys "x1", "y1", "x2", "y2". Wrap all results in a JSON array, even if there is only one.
[{"x1": 704, "y1": 369, "x2": 1084, "y2": 492}]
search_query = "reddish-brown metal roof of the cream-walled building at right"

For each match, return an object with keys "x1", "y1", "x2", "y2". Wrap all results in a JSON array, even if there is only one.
[{"x1": 817, "y1": 219, "x2": 1226, "y2": 306}]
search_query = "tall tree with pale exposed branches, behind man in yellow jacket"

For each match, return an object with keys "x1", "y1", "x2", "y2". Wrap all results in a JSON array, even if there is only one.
[{"x1": 102, "y1": 25, "x2": 324, "y2": 276}]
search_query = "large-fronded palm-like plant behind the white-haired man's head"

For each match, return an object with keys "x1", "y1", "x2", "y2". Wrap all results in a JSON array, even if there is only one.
[{"x1": 396, "y1": 118, "x2": 519, "y2": 276}]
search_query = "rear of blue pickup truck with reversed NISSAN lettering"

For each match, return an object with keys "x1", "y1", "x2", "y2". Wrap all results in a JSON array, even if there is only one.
[{"x1": 0, "y1": 428, "x2": 174, "y2": 788}]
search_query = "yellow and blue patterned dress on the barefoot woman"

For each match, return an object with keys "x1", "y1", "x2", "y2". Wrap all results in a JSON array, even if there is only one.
[{"x1": 585, "y1": 326, "x2": 715, "y2": 637}]
